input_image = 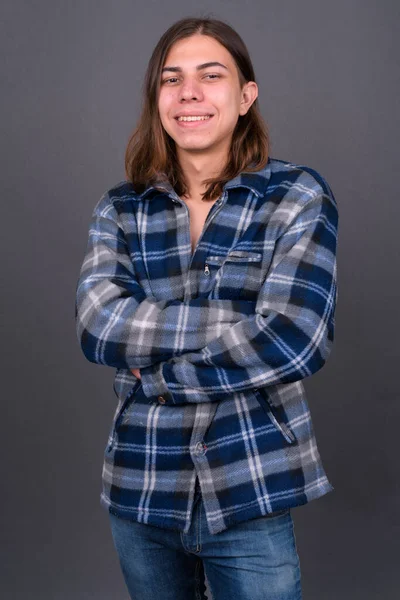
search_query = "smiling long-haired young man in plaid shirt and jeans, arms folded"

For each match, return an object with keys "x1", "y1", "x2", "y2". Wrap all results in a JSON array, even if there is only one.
[{"x1": 76, "y1": 14, "x2": 338, "y2": 600}]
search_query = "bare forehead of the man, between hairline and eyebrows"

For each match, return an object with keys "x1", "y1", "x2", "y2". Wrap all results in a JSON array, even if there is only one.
[{"x1": 163, "y1": 34, "x2": 235, "y2": 70}]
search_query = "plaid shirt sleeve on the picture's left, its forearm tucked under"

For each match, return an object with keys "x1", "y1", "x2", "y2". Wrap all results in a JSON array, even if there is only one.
[{"x1": 75, "y1": 194, "x2": 255, "y2": 369}]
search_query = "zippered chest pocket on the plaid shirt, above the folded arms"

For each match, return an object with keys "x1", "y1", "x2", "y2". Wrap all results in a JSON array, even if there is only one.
[{"x1": 204, "y1": 250, "x2": 262, "y2": 300}]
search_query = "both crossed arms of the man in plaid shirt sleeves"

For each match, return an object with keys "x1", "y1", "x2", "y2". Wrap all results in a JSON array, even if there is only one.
[{"x1": 76, "y1": 189, "x2": 338, "y2": 405}]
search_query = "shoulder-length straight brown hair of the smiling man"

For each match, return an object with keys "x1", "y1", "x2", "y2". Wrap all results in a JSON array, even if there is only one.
[{"x1": 125, "y1": 17, "x2": 269, "y2": 200}]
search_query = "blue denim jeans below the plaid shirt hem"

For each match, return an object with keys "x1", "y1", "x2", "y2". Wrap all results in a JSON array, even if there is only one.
[{"x1": 109, "y1": 482, "x2": 302, "y2": 600}]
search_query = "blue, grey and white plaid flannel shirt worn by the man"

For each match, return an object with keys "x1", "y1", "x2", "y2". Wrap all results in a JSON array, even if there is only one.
[{"x1": 75, "y1": 158, "x2": 338, "y2": 534}]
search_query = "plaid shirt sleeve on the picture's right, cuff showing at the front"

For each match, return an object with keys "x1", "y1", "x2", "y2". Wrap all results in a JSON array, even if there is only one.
[{"x1": 141, "y1": 190, "x2": 338, "y2": 405}]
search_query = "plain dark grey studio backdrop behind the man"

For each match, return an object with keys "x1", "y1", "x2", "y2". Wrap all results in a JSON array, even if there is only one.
[{"x1": 0, "y1": 0, "x2": 400, "y2": 600}]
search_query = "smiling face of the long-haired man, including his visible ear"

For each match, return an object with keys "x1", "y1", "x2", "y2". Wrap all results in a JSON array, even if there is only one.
[{"x1": 158, "y1": 35, "x2": 258, "y2": 155}]
